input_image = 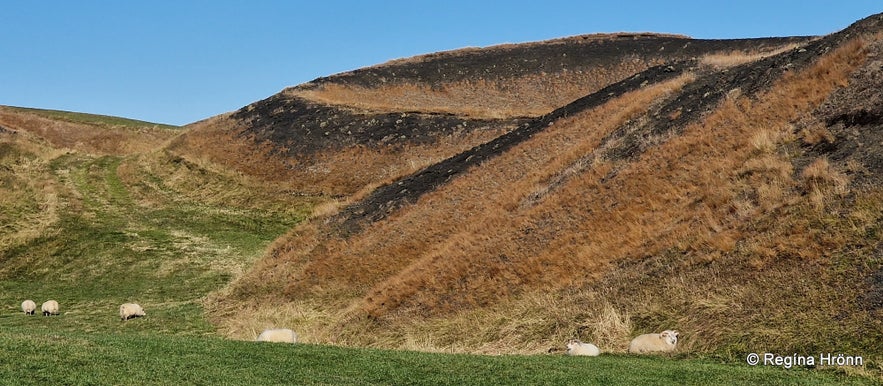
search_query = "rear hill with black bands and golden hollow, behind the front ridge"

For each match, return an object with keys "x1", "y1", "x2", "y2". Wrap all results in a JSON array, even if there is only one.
[{"x1": 172, "y1": 34, "x2": 812, "y2": 197}]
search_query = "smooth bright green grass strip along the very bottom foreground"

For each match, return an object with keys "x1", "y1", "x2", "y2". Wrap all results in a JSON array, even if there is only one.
[{"x1": 0, "y1": 328, "x2": 875, "y2": 385}]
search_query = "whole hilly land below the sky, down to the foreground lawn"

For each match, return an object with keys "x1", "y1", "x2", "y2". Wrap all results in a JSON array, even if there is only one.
[{"x1": 0, "y1": 14, "x2": 883, "y2": 379}]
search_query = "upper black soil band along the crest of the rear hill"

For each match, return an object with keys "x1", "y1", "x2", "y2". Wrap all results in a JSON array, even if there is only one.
[{"x1": 308, "y1": 34, "x2": 811, "y2": 88}]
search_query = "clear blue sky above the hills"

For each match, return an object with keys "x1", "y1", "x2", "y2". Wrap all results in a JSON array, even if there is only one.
[{"x1": 0, "y1": 0, "x2": 883, "y2": 124}]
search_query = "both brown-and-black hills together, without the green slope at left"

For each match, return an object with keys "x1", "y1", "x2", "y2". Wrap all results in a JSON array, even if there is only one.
[{"x1": 204, "y1": 15, "x2": 883, "y2": 359}]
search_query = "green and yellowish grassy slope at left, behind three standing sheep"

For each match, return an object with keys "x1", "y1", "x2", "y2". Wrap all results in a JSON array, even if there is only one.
[{"x1": 0, "y1": 109, "x2": 307, "y2": 334}]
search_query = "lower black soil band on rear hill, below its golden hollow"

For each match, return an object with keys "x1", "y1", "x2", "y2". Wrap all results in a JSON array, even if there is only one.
[{"x1": 232, "y1": 93, "x2": 521, "y2": 158}]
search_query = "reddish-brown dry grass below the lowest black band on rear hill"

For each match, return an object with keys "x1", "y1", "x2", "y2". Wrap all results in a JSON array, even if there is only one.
[{"x1": 169, "y1": 112, "x2": 504, "y2": 196}]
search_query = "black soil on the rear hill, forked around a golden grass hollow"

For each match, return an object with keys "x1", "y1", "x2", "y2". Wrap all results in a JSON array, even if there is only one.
[{"x1": 232, "y1": 34, "x2": 811, "y2": 162}]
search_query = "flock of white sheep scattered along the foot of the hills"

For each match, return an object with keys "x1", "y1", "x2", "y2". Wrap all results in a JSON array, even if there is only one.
[{"x1": 21, "y1": 300, "x2": 679, "y2": 357}]
